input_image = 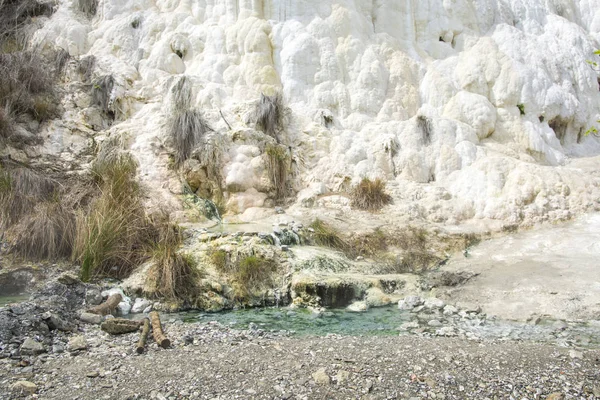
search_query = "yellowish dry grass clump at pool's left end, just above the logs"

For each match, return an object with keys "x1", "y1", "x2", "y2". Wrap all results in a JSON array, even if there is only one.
[{"x1": 148, "y1": 220, "x2": 200, "y2": 300}]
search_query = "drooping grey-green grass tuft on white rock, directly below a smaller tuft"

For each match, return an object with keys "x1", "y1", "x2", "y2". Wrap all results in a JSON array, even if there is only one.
[{"x1": 167, "y1": 109, "x2": 211, "y2": 166}]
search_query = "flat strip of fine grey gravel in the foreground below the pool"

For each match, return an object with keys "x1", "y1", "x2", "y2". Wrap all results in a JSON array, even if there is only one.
[{"x1": 0, "y1": 323, "x2": 600, "y2": 400}]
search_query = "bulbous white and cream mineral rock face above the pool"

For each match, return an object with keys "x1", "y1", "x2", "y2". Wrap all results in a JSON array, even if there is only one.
[{"x1": 30, "y1": 0, "x2": 600, "y2": 223}]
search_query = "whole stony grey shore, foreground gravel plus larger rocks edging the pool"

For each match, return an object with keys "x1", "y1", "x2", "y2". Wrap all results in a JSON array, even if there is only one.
[{"x1": 0, "y1": 273, "x2": 600, "y2": 400}]
